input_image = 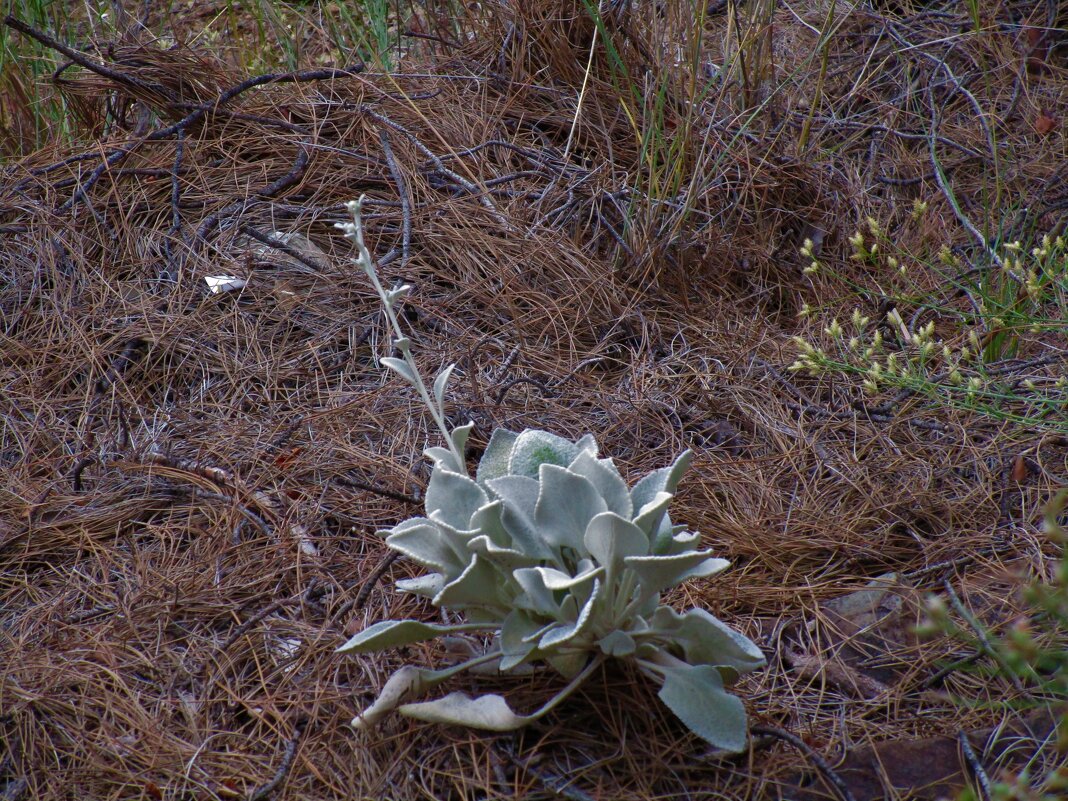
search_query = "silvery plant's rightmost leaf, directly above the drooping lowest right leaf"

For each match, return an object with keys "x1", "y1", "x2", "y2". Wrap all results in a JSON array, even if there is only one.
[{"x1": 649, "y1": 607, "x2": 767, "y2": 673}]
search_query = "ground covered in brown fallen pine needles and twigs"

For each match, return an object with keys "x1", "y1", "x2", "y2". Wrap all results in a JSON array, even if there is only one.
[{"x1": 0, "y1": 0, "x2": 1068, "y2": 801}]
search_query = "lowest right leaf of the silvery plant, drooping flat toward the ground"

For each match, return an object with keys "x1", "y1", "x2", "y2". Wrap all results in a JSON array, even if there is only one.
[{"x1": 657, "y1": 663, "x2": 748, "y2": 753}]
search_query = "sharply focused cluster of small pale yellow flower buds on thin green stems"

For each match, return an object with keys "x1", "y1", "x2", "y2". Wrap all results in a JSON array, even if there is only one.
[{"x1": 788, "y1": 223, "x2": 1068, "y2": 414}]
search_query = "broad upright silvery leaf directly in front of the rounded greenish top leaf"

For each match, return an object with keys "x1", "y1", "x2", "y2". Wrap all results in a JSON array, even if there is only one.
[{"x1": 534, "y1": 465, "x2": 608, "y2": 553}]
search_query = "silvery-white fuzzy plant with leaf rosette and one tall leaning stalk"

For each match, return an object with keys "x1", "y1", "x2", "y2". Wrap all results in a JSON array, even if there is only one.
[{"x1": 337, "y1": 198, "x2": 765, "y2": 752}]
